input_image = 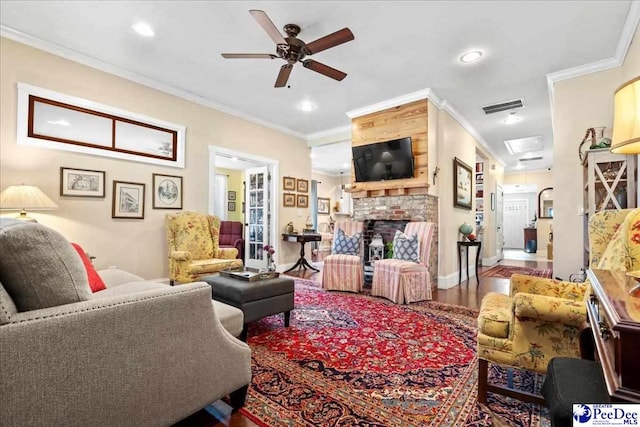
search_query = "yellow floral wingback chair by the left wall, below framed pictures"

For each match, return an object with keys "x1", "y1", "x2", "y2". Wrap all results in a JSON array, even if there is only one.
[{"x1": 167, "y1": 212, "x2": 242, "y2": 285}]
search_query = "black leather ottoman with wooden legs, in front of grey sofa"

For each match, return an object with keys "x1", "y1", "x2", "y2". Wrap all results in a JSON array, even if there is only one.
[{"x1": 199, "y1": 274, "x2": 294, "y2": 340}]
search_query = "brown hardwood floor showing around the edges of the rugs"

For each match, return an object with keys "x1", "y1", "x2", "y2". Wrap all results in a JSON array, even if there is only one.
[{"x1": 176, "y1": 252, "x2": 553, "y2": 427}]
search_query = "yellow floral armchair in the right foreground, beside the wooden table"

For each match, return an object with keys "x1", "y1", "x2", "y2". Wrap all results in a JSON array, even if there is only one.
[{"x1": 477, "y1": 209, "x2": 640, "y2": 404}]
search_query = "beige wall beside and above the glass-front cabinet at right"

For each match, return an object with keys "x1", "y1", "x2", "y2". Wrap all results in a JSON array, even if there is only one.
[{"x1": 553, "y1": 31, "x2": 640, "y2": 279}]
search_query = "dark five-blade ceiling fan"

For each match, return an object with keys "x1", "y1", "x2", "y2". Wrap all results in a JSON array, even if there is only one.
[{"x1": 222, "y1": 10, "x2": 354, "y2": 87}]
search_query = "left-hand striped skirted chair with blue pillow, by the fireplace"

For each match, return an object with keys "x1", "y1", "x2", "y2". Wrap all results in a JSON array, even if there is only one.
[{"x1": 322, "y1": 221, "x2": 364, "y2": 292}]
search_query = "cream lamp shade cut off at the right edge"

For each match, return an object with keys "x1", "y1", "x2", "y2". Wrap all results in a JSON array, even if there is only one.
[{"x1": 611, "y1": 76, "x2": 640, "y2": 154}]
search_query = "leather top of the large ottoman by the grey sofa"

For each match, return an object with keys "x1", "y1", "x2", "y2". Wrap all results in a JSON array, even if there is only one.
[{"x1": 200, "y1": 275, "x2": 294, "y2": 304}]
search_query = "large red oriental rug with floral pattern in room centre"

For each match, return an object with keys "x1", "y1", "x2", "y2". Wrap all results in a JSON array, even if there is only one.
[{"x1": 241, "y1": 280, "x2": 549, "y2": 427}]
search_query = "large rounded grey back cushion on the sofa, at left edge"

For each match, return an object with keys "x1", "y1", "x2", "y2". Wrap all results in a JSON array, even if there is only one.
[{"x1": 0, "y1": 218, "x2": 91, "y2": 311}]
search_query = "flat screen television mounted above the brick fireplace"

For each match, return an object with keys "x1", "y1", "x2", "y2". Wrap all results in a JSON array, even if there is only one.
[{"x1": 351, "y1": 137, "x2": 413, "y2": 182}]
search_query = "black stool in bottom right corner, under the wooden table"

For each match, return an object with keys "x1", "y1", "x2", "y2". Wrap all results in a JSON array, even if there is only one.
[{"x1": 542, "y1": 357, "x2": 610, "y2": 427}]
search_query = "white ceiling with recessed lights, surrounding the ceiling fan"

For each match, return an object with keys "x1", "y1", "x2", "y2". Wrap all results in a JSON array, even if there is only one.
[{"x1": 0, "y1": 0, "x2": 640, "y2": 173}]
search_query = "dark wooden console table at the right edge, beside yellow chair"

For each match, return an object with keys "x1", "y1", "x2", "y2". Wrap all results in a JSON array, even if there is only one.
[{"x1": 587, "y1": 269, "x2": 640, "y2": 403}]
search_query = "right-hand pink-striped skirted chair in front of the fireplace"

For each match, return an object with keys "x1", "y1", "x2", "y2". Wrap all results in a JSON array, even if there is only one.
[{"x1": 371, "y1": 222, "x2": 436, "y2": 304}]
